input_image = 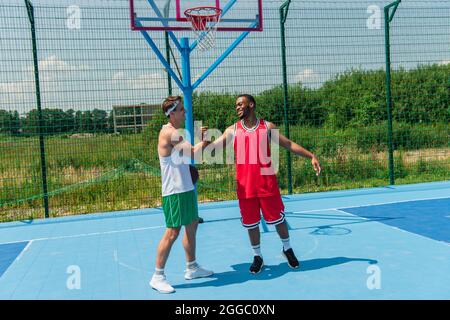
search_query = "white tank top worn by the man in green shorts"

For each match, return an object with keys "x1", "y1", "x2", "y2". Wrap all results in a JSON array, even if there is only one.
[{"x1": 159, "y1": 125, "x2": 194, "y2": 197}]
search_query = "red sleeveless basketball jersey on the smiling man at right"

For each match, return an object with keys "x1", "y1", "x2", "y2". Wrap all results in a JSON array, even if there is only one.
[{"x1": 234, "y1": 119, "x2": 280, "y2": 199}]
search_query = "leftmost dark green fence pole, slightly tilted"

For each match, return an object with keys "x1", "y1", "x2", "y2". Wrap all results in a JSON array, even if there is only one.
[{"x1": 25, "y1": 0, "x2": 50, "y2": 218}]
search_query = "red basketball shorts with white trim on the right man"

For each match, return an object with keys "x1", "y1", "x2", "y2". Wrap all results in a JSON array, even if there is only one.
[{"x1": 239, "y1": 195, "x2": 284, "y2": 229}]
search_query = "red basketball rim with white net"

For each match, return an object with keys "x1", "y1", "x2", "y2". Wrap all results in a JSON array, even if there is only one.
[{"x1": 184, "y1": 7, "x2": 222, "y2": 50}]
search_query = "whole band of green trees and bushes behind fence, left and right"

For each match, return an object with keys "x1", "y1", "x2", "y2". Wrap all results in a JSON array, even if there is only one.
[{"x1": 0, "y1": 64, "x2": 450, "y2": 135}]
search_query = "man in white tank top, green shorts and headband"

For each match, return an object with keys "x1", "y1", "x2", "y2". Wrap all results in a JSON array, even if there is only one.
[{"x1": 150, "y1": 96, "x2": 213, "y2": 293}]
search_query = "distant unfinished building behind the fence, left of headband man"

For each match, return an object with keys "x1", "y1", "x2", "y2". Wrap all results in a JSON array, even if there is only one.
[{"x1": 113, "y1": 103, "x2": 161, "y2": 133}]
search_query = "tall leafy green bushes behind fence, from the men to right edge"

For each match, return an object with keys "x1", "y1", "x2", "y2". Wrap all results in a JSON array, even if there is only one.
[{"x1": 193, "y1": 64, "x2": 450, "y2": 130}]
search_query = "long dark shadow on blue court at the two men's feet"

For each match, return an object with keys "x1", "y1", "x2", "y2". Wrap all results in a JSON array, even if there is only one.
[{"x1": 173, "y1": 257, "x2": 378, "y2": 289}]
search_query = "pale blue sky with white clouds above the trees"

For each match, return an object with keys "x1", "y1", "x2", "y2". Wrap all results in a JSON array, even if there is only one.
[{"x1": 0, "y1": 0, "x2": 450, "y2": 114}]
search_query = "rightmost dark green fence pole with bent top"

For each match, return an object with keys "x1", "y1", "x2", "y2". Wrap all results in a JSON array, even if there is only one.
[{"x1": 384, "y1": 0, "x2": 401, "y2": 185}]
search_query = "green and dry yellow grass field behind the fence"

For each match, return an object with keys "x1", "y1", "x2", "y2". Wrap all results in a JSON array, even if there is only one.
[{"x1": 0, "y1": 125, "x2": 450, "y2": 221}]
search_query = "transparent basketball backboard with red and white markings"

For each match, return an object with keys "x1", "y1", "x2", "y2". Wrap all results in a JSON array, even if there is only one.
[{"x1": 129, "y1": 0, "x2": 263, "y2": 31}]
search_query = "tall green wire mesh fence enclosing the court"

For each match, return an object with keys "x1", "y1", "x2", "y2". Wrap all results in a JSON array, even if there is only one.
[{"x1": 0, "y1": 0, "x2": 450, "y2": 221}]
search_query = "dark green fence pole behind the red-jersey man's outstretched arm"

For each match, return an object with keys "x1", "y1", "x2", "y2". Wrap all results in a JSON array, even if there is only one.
[{"x1": 280, "y1": 0, "x2": 292, "y2": 194}]
